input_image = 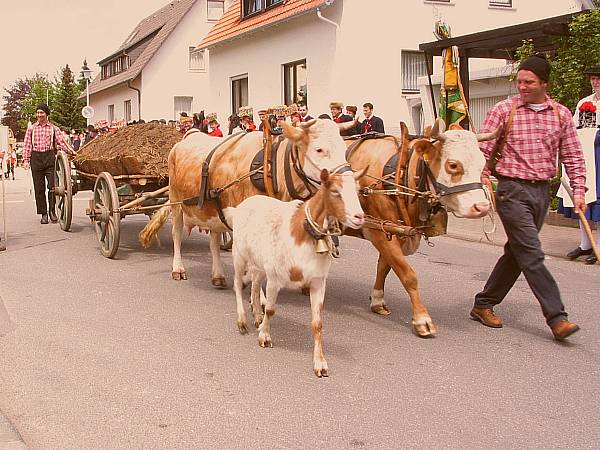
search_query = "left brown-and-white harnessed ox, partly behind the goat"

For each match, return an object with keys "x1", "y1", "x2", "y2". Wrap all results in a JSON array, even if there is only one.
[{"x1": 140, "y1": 119, "x2": 356, "y2": 287}]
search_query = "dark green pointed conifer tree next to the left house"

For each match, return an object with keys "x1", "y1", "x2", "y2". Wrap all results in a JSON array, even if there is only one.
[{"x1": 52, "y1": 64, "x2": 86, "y2": 130}]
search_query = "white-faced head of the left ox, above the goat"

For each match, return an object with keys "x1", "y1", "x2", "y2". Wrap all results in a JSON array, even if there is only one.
[{"x1": 281, "y1": 119, "x2": 346, "y2": 180}]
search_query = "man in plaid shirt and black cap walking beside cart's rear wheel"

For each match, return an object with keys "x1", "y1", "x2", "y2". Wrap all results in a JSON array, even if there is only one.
[{"x1": 23, "y1": 103, "x2": 75, "y2": 224}]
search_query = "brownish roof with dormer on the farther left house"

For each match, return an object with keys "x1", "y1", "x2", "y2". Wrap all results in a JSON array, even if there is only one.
[{"x1": 82, "y1": 0, "x2": 196, "y2": 96}]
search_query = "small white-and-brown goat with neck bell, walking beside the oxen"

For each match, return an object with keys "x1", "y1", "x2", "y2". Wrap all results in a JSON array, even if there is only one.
[{"x1": 232, "y1": 165, "x2": 365, "y2": 377}]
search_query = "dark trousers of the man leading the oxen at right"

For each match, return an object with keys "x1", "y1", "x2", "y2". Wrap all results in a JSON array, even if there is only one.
[{"x1": 475, "y1": 179, "x2": 567, "y2": 325}]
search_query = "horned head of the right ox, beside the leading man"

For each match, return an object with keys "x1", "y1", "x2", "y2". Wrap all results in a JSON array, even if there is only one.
[{"x1": 413, "y1": 119, "x2": 500, "y2": 219}]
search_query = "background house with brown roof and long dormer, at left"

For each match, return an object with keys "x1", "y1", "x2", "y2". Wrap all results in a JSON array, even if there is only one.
[{"x1": 89, "y1": 0, "x2": 231, "y2": 123}]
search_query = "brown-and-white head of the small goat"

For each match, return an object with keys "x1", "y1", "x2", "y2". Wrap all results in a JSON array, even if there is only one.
[{"x1": 315, "y1": 166, "x2": 368, "y2": 229}]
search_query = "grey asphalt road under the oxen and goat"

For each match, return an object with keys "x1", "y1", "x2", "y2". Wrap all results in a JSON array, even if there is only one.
[{"x1": 0, "y1": 171, "x2": 600, "y2": 449}]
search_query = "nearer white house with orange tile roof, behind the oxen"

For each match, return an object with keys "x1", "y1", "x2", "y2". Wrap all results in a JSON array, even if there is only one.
[{"x1": 198, "y1": 0, "x2": 581, "y2": 132}]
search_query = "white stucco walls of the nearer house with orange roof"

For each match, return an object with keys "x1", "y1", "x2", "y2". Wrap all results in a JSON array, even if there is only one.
[{"x1": 209, "y1": 0, "x2": 577, "y2": 132}]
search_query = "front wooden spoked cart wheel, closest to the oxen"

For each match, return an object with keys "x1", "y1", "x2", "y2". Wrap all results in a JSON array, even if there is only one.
[{"x1": 93, "y1": 172, "x2": 121, "y2": 258}]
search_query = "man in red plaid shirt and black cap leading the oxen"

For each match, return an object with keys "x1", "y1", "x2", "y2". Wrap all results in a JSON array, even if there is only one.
[{"x1": 471, "y1": 56, "x2": 586, "y2": 340}]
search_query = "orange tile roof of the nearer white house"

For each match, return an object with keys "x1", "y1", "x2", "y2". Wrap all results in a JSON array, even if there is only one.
[{"x1": 198, "y1": 0, "x2": 327, "y2": 48}]
